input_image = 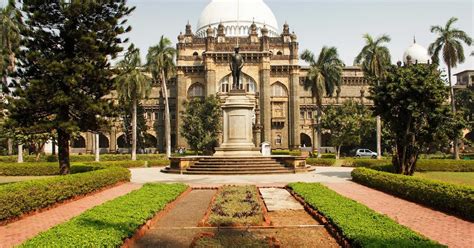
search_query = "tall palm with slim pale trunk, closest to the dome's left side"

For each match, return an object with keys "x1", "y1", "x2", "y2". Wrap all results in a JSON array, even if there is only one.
[{"x1": 147, "y1": 36, "x2": 176, "y2": 157}]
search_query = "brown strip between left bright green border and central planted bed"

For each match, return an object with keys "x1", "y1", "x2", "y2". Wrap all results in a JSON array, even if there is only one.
[{"x1": 132, "y1": 190, "x2": 216, "y2": 248}]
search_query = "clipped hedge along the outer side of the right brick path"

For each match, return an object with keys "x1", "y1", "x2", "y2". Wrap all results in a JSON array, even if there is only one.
[{"x1": 352, "y1": 168, "x2": 474, "y2": 221}]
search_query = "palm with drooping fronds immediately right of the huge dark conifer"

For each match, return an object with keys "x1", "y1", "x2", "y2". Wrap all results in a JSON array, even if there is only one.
[{"x1": 116, "y1": 44, "x2": 151, "y2": 160}]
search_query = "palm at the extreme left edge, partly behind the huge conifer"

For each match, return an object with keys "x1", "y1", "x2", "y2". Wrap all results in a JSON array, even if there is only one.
[{"x1": 0, "y1": 0, "x2": 21, "y2": 155}]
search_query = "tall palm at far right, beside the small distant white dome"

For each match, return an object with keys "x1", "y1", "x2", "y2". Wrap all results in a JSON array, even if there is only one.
[{"x1": 428, "y1": 17, "x2": 472, "y2": 159}]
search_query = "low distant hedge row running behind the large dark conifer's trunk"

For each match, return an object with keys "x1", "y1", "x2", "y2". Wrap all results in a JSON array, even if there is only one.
[{"x1": 0, "y1": 154, "x2": 166, "y2": 163}]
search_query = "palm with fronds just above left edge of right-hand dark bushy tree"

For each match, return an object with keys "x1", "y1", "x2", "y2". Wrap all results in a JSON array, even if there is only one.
[{"x1": 354, "y1": 34, "x2": 391, "y2": 159}]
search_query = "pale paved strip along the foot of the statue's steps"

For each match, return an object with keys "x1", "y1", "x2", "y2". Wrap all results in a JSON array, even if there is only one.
[{"x1": 131, "y1": 167, "x2": 352, "y2": 187}]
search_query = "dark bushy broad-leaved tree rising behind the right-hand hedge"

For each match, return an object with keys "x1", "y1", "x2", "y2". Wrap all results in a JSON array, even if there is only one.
[{"x1": 370, "y1": 64, "x2": 453, "y2": 175}]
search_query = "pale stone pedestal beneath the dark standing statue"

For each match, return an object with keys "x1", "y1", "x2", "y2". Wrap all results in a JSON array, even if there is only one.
[{"x1": 214, "y1": 90, "x2": 262, "y2": 157}]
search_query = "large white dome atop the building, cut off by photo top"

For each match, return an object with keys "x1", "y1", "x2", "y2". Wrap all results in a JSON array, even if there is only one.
[{"x1": 196, "y1": 0, "x2": 279, "y2": 37}]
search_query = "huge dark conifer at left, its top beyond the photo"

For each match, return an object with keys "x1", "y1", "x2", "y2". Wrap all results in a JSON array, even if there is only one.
[{"x1": 8, "y1": 0, "x2": 134, "y2": 174}]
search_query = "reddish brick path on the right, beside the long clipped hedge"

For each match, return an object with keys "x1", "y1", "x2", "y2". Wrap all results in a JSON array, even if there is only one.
[{"x1": 324, "y1": 182, "x2": 474, "y2": 248}]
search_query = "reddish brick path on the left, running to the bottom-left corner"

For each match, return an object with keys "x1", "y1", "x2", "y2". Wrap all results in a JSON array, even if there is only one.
[{"x1": 0, "y1": 183, "x2": 141, "y2": 248}]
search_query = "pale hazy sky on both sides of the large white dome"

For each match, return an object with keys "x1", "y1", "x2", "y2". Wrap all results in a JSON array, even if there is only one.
[{"x1": 124, "y1": 0, "x2": 474, "y2": 79}]
